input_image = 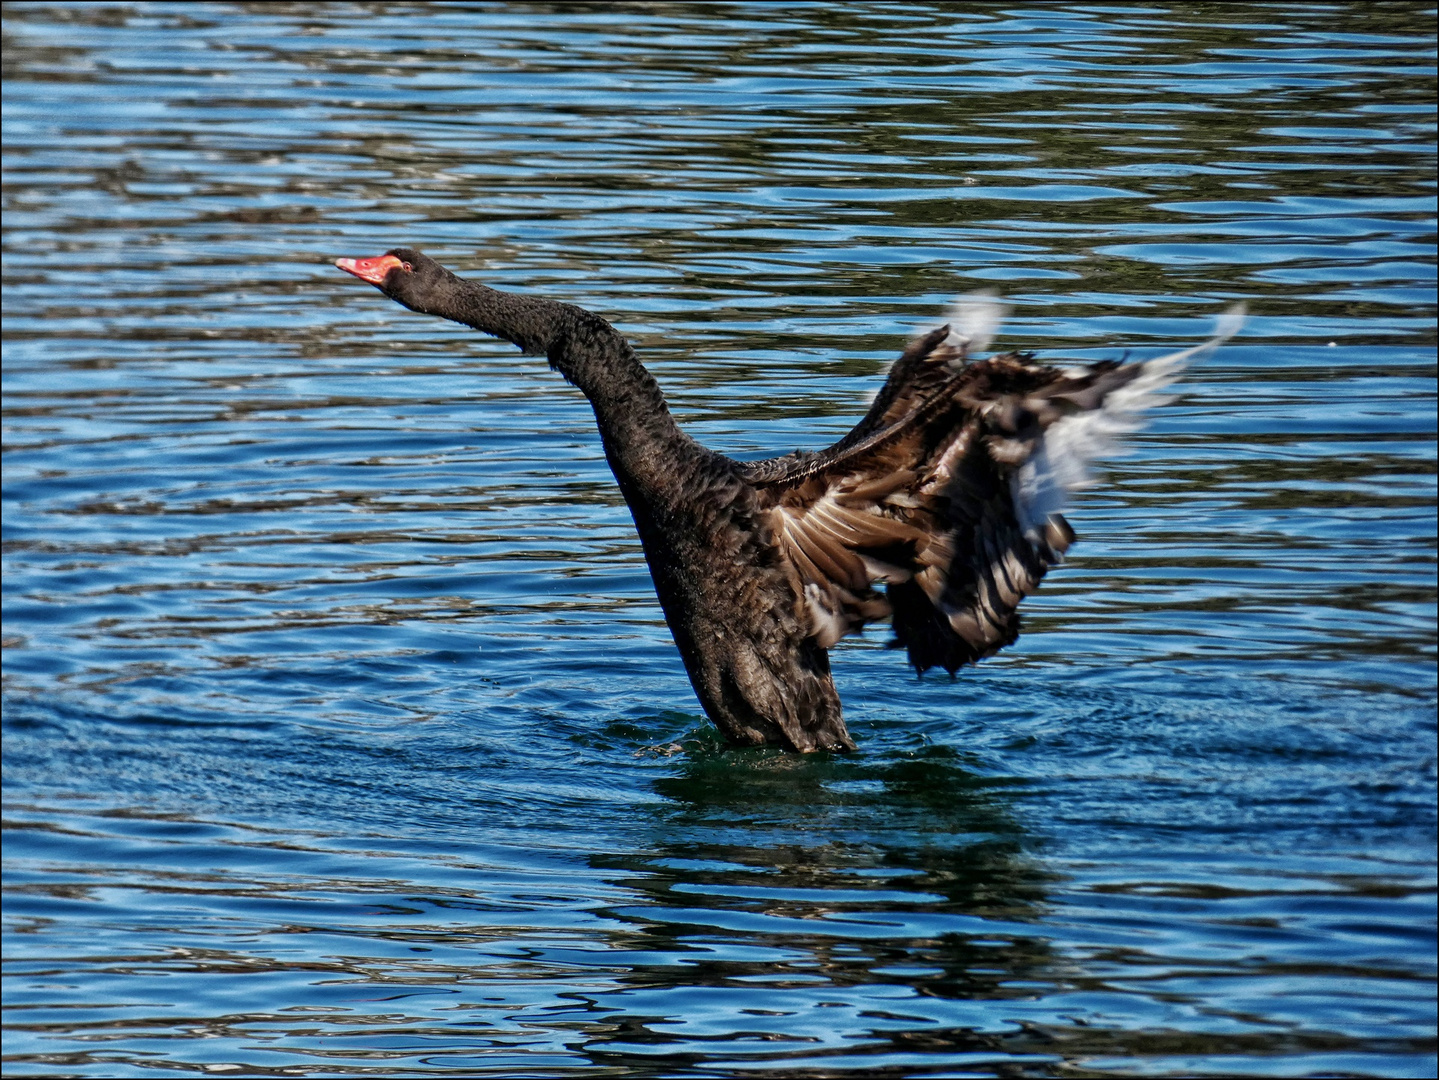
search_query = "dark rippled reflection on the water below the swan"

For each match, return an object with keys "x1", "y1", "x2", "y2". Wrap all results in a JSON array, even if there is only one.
[{"x1": 584, "y1": 743, "x2": 1056, "y2": 1068}]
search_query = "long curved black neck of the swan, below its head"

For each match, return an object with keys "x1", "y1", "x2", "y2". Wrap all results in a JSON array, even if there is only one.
[{"x1": 416, "y1": 275, "x2": 708, "y2": 499}]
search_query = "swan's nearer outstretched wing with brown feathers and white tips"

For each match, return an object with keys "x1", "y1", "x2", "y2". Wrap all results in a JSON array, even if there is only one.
[{"x1": 745, "y1": 309, "x2": 1242, "y2": 673}]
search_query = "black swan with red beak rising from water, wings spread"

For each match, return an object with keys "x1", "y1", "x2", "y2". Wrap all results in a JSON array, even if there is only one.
[{"x1": 335, "y1": 247, "x2": 1242, "y2": 751}]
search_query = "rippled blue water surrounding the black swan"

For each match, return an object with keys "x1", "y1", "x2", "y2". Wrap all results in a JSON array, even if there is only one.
[{"x1": 4, "y1": 3, "x2": 1435, "y2": 1077}]
